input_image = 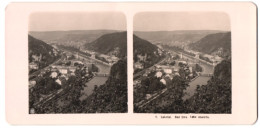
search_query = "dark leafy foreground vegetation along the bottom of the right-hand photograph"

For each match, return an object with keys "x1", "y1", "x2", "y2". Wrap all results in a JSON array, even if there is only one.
[{"x1": 134, "y1": 60, "x2": 232, "y2": 114}]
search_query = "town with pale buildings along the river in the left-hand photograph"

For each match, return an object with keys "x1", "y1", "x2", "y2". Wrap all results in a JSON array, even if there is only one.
[{"x1": 29, "y1": 44, "x2": 119, "y2": 114}]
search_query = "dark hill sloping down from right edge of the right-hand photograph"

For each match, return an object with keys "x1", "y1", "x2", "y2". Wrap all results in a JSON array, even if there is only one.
[{"x1": 189, "y1": 32, "x2": 231, "y2": 56}]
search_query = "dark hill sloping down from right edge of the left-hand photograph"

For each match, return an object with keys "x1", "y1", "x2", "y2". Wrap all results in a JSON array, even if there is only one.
[{"x1": 84, "y1": 32, "x2": 127, "y2": 58}]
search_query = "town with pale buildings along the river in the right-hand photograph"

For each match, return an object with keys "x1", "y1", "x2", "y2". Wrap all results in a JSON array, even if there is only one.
[{"x1": 134, "y1": 45, "x2": 223, "y2": 112}]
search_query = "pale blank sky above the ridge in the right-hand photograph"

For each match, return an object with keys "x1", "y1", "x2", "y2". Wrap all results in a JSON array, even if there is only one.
[{"x1": 134, "y1": 12, "x2": 230, "y2": 31}]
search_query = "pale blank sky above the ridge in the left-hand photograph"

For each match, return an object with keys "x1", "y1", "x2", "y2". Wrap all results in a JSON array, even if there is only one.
[{"x1": 28, "y1": 12, "x2": 126, "y2": 31}]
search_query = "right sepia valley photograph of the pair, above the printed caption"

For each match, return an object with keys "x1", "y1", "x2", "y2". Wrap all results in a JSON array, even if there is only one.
[{"x1": 133, "y1": 12, "x2": 232, "y2": 114}]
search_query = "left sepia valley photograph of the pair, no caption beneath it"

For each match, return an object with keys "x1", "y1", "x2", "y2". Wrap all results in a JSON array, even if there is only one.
[{"x1": 28, "y1": 12, "x2": 128, "y2": 114}]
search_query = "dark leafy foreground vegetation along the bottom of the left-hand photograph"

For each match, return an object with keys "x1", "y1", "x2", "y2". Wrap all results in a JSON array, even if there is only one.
[{"x1": 29, "y1": 59, "x2": 127, "y2": 113}]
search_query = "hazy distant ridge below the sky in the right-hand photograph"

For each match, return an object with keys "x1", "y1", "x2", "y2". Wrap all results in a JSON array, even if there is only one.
[{"x1": 134, "y1": 30, "x2": 223, "y2": 46}]
